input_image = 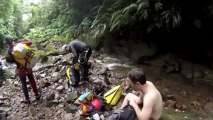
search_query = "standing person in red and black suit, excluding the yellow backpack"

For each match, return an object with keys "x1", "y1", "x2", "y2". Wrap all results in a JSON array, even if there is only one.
[{"x1": 5, "y1": 36, "x2": 40, "y2": 104}]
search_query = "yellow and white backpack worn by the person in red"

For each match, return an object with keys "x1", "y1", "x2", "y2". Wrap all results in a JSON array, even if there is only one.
[{"x1": 12, "y1": 43, "x2": 38, "y2": 69}]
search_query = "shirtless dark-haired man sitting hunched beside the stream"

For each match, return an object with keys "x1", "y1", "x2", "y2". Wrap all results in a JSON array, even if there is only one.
[{"x1": 121, "y1": 68, "x2": 163, "y2": 120}]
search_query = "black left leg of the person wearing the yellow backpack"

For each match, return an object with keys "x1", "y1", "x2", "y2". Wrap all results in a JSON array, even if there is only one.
[{"x1": 19, "y1": 75, "x2": 30, "y2": 102}]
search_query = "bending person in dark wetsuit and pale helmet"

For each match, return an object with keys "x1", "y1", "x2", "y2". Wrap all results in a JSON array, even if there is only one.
[{"x1": 62, "y1": 39, "x2": 92, "y2": 84}]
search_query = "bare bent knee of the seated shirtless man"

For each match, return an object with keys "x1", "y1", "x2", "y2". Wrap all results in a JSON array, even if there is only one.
[{"x1": 121, "y1": 93, "x2": 141, "y2": 108}]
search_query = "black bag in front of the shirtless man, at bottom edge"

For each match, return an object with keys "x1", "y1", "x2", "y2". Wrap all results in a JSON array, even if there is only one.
[{"x1": 107, "y1": 105, "x2": 137, "y2": 120}]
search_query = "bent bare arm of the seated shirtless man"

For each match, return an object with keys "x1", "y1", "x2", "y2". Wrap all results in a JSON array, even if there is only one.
[{"x1": 130, "y1": 96, "x2": 154, "y2": 120}]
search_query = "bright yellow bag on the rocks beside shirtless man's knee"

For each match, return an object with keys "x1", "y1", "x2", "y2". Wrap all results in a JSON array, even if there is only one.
[{"x1": 104, "y1": 85, "x2": 123, "y2": 105}]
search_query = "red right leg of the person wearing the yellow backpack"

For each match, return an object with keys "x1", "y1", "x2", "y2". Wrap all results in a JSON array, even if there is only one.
[{"x1": 27, "y1": 73, "x2": 40, "y2": 100}]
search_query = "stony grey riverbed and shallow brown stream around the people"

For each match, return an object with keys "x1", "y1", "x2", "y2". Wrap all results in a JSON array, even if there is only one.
[{"x1": 0, "y1": 52, "x2": 213, "y2": 120}]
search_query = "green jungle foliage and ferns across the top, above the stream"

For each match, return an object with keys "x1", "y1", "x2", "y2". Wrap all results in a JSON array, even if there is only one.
[{"x1": 0, "y1": 0, "x2": 213, "y2": 51}]
